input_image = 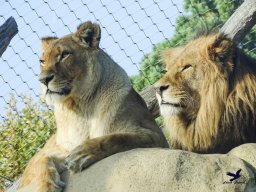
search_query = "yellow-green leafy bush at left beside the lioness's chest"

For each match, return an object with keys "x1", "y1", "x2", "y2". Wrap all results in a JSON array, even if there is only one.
[{"x1": 0, "y1": 95, "x2": 56, "y2": 187}]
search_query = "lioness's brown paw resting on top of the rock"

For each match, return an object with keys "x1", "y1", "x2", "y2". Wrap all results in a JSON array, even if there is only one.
[{"x1": 65, "y1": 148, "x2": 100, "y2": 173}]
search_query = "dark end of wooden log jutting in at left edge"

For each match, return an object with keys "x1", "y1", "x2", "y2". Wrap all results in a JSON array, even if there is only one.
[{"x1": 0, "y1": 17, "x2": 18, "y2": 57}]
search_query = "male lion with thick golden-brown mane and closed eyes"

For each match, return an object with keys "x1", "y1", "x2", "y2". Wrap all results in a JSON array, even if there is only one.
[{"x1": 156, "y1": 33, "x2": 256, "y2": 153}]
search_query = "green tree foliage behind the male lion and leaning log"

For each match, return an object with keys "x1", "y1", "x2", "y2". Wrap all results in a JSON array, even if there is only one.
[{"x1": 131, "y1": 0, "x2": 256, "y2": 91}]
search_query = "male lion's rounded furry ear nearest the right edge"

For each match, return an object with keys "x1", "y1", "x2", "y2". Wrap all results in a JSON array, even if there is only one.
[{"x1": 207, "y1": 34, "x2": 233, "y2": 65}]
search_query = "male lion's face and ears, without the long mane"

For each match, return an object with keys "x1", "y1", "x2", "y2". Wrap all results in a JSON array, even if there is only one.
[{"x1": 155, "y1": 34, "x2": 233, "y2": 121}]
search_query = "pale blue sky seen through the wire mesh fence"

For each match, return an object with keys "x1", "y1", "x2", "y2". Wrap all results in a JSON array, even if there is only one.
[{"x1": 0, "y1": 0, "x2": 183, "y2": 119}]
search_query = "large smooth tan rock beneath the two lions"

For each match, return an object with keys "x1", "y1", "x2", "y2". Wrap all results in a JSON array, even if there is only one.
[{"x1": 15, "y1": 144, "x2": 256, "y2": 192}]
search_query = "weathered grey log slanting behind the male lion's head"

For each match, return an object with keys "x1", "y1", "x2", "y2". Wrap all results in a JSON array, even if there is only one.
[{"x1": 140, "y1": 0, "x2": 256, "y2": 118}]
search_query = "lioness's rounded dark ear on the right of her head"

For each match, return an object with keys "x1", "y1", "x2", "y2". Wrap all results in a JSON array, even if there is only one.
[{"x1": 73, "y1": 21, "x2": 101, "y2": 48}]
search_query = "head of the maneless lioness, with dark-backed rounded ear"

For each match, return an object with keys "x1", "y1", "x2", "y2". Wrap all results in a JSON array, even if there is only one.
[{"x1": 39, "y1": 22, "x2": 101, "y2": 108}]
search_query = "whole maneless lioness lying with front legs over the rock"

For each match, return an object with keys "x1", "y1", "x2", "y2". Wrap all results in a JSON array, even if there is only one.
[{"x1": 19, "y1": 22, "x2": 168, "y2": 192}]
